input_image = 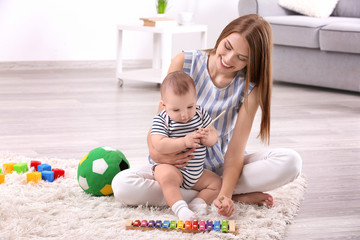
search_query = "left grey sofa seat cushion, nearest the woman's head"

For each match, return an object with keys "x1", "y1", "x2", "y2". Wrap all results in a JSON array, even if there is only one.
[{"x1": 264, "y1": 15, "x2": 348, "y2": 48}]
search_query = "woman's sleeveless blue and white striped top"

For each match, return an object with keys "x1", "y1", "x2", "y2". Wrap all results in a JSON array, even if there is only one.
[{"x1": 183, "y1": 50, "x2": 255, "y2": 175}]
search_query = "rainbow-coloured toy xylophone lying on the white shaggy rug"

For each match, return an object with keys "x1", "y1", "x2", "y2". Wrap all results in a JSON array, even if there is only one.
[{"x1": 125, "y1": 220, "x2": 238, "y2": 234}]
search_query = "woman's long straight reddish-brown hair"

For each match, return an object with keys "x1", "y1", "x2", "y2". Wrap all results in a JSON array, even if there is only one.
[{"x1": 210, "y1": 14, "x2": 272, "y2": 144}]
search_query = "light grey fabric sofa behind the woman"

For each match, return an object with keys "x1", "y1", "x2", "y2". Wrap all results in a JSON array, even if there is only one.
[{"x1": 238, "y1": 0, "x2": 360, "y2": 92}]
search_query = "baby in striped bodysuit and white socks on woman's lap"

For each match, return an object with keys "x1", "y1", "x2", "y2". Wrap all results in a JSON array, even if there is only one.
[{"x1": 150, "y1": 71, "x2": 221, "y2": 220}]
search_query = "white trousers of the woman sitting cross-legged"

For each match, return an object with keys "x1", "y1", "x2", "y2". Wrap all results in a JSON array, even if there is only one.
[{"x1": 111, "y1": 148, "x2": 302, "y2": 206}]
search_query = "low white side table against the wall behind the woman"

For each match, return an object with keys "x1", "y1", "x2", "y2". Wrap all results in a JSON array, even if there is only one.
[{"x1": 116, "y1": 24, "x2": 207, "y2": 86}]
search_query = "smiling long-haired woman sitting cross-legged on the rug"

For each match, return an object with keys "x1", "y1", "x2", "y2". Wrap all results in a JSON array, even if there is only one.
[{"x1": 112, "y1": 14, "x2": 302, "y2": 216}]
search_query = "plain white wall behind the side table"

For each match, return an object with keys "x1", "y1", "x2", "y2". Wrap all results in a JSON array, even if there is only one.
[{"x1": 0, "y1": 0, "x2": 238, "y2": 62}]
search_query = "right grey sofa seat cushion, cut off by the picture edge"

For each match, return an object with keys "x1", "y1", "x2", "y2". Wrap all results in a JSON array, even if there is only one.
[{"x1": 319, "y1": 19, "x2": 360, "y2": 53}]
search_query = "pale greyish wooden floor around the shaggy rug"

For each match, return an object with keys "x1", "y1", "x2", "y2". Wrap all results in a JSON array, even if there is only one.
[{"x1": 0, "y1": 69, "x2": 360, "y2": 240}]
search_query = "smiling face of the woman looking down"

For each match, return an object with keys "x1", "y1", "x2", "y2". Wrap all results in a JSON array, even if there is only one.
[{"x1": 216, "y1": 33, "x2": 249, "y2": 72}]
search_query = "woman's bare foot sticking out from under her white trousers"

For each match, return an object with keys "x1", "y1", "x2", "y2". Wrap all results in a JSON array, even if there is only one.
[{"x1": 232, "y1": 192, "x2": 274, "y2": 207}]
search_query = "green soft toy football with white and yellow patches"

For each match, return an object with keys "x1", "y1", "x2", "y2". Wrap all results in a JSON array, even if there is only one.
[{"x1": 77, "y1": 147, "x2": 130, "y2": 196}]
